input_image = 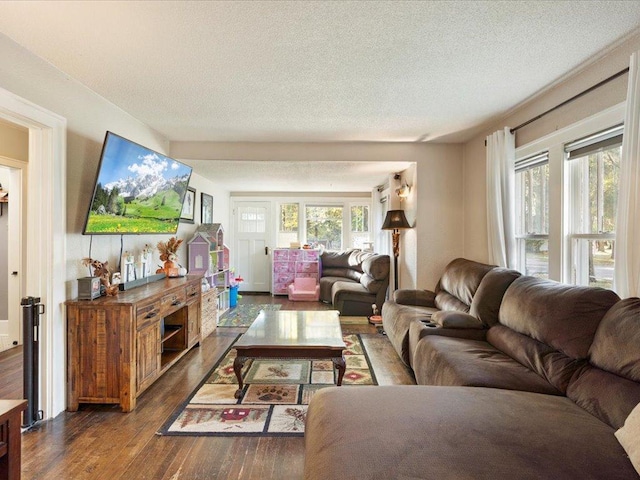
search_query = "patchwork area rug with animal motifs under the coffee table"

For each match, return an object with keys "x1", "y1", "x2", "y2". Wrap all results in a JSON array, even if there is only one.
[{"x1": 158, "y1": 334, "x2": 378, "y2": 436}]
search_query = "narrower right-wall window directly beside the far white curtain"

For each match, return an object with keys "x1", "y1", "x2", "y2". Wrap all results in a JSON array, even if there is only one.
[{"x1": 515, "y1": 152, "x2": 549, "y2": 278}]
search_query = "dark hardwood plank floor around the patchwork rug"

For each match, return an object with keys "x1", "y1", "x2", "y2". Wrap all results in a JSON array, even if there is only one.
[{"x1": 0, "y1": 294, "x2": 415, "y2": 480}]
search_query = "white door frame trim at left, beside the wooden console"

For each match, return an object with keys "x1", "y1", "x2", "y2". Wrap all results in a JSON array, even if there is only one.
[{"x1": 0, "y1": 88, "x2": 67, "y2": 419}]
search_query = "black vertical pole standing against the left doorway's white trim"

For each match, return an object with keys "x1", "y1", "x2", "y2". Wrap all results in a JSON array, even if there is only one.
[{"x1": 20, "y1": 297, "x2": 43, "y2": 428}]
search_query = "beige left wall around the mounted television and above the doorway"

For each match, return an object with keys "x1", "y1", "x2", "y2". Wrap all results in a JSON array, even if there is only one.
[{"x1": 0, "y1": 35, "x2": 222, "y2": 297}]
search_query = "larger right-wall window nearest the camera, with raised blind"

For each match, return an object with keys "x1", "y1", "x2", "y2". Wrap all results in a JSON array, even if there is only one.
[{"x1": 565, "y1": 126, "x2": 622, "y2": 288}]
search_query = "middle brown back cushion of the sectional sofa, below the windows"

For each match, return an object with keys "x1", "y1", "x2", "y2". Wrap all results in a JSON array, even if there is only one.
[{"x1": 499, "y1": 276, "x2": 619, "y2": 359}]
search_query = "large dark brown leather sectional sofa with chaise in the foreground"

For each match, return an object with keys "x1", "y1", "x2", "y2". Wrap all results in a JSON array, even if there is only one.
[{"x1": 305, "y1": 259, "x2": 640, "y2": 480}]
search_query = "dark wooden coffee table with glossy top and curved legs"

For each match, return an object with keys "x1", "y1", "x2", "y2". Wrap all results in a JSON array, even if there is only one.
[{"x1": 233, "y1": 310, "x2": 346, "y2": 398}]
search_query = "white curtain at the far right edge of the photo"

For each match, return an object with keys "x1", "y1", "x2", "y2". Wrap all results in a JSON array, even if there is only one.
[{"x1": 614, "y1": 52, "x2": 640, "y2": 298}]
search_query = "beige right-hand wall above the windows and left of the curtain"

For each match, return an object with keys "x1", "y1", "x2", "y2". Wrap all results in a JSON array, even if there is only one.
[{"x1": 462, "y1": 34, "x2": 640, "y2": 261}]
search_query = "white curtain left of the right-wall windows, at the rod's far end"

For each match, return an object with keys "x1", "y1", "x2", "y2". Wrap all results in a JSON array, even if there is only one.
[{"x1": 487, "y1": 127, "x2": 516, "y2": 268}]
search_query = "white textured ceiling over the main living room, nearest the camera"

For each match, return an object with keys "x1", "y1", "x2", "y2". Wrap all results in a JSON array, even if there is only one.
[{"x1": 0, "y1": 0, "x2": 640, "y2": 190}]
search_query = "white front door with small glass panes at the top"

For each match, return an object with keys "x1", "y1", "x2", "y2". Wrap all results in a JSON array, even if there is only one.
[{"x1": 233, "y1": 201, "x2": 271, "y2": 292}]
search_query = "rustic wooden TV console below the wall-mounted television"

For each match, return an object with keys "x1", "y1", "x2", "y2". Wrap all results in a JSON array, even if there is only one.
[{"x1": 66, "y1": 276, "x2": 201, "y2": 412}]
